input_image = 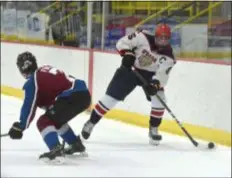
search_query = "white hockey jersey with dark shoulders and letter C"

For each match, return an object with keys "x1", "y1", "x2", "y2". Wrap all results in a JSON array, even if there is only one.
[{"x1": 116, "y1": 31, "x2": 176, "y2": 86}]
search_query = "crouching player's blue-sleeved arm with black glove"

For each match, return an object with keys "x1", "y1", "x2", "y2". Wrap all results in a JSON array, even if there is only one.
[{"x1": 9, "y1": 73, "x2": 38, "y2": 139}]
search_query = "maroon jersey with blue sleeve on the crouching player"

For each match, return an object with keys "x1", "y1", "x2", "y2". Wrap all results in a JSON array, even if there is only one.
[{"x1": 20, "y1": 66, "x2": 74, "y2": 129}]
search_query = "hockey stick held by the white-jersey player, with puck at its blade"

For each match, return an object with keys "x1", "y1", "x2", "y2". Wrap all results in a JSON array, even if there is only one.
[{"x1": 133, "y1": 69, "x2": 214, "y2": 149}]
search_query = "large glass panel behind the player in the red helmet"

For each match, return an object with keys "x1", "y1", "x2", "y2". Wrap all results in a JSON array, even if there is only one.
[{"x1": 104, "y1": 1, "x2": 232, "y2": 60}]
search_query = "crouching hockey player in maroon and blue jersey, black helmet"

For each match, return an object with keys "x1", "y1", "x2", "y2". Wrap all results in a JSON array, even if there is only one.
[{"x1": 8, "y1": 52, "x2": 91, "y2": 162}]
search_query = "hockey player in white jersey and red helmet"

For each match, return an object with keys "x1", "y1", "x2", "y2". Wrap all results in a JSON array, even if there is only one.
[{"x1": 82, "y1": 24, "x2": 176, "y2": 145}]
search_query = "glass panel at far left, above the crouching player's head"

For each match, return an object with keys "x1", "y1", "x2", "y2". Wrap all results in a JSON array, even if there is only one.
[{"x1": 1, "y1": 1, "x2": 86, "y2": 47}]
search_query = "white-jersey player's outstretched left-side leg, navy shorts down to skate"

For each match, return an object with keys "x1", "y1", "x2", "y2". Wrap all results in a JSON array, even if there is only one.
[{"x1": 81, "y1": 67, "x2": 138, "y2": 139}]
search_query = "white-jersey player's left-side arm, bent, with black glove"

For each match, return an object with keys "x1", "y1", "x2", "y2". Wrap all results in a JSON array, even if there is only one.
[{"x1": 116, "y1": 31, "x2": 141, "y2": 69}]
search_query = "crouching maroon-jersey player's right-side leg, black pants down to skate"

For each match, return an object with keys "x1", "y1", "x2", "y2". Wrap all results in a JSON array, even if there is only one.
[{"x1": 48, "y1": 90, "x2": 91, "y2": 154}]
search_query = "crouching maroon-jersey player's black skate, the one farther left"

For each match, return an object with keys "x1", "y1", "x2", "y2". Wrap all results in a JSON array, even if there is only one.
[{"x1": 39, "y1": 144, "x2": 64, "y2": 164}]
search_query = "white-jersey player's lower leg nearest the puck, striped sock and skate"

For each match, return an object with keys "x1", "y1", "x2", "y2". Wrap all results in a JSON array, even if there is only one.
[{"x1": 149, "y1": 90, "x2": 165, "y2": 145}]
